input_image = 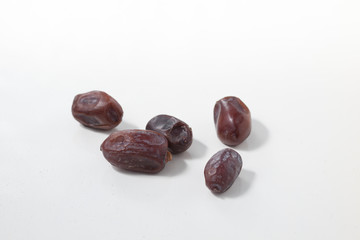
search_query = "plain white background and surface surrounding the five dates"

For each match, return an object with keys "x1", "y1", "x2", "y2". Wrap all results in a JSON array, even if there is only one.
[{"x1": 0, "y1": 0, "x2": 360, "y2": 240}]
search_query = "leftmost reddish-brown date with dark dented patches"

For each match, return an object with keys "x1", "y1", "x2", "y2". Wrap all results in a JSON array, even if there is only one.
[{"x1": 72, "y1": 91, "x2": 124, "y2": 130}]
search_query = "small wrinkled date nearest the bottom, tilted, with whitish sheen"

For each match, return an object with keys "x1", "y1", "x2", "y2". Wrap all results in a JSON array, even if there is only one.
[{"x1": 204, "y1": 148, "x2": 242, "y2": 193}]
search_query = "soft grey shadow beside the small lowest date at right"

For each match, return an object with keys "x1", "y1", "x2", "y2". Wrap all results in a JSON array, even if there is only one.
[{"x1": 214, "y1": 169, "x2": 255, "y2": 198}]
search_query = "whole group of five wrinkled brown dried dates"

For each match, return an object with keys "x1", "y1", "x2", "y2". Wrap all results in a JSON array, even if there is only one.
[{"x1": 72, "y1": 91, "x2": 251, "y2": 193}]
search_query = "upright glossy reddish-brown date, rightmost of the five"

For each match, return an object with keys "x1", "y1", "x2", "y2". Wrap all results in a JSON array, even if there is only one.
[{"x1": 214, "y1": 97, "x2": 251, "y2": 146}]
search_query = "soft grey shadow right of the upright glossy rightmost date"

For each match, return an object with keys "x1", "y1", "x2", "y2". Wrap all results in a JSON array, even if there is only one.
[{"x1": 236, "y1": 119, "x2": 269, "y2": 151}]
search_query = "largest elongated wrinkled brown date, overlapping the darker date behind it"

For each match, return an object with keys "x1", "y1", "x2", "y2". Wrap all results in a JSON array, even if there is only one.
[{"x1": 100, "y1": 130, "x2": 171, "y2": 173}]
